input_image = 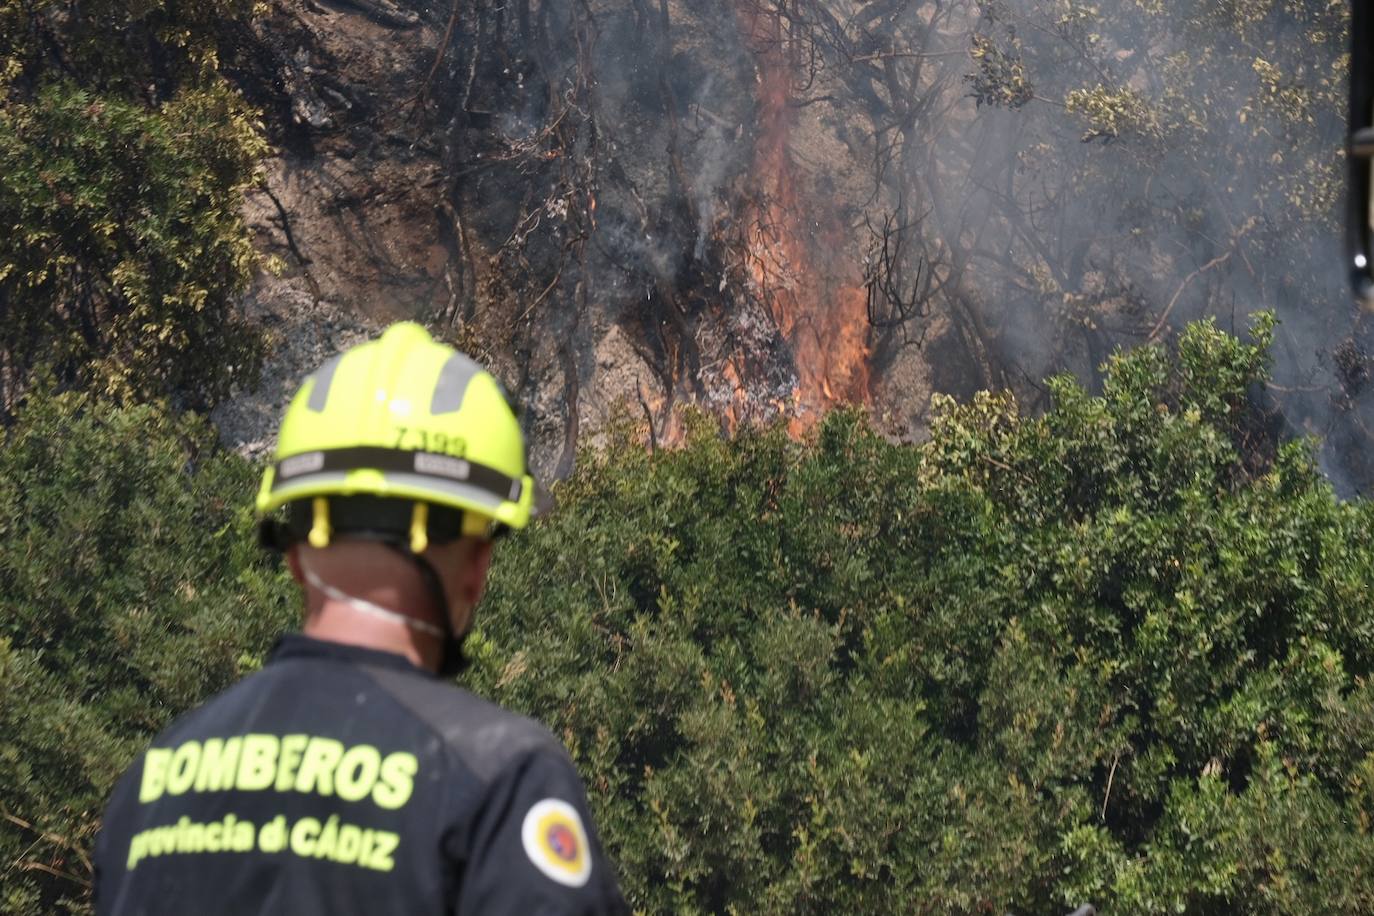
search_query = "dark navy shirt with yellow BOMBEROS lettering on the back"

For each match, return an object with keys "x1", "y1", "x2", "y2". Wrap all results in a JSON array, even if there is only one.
[{"x1": 95, "y1": 636, "x2": 628, "y2": 916}]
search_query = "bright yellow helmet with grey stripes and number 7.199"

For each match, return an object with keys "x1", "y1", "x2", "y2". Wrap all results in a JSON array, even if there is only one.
[{"x1": 257, "y1": 321, "x2": 544, "y2": 553}]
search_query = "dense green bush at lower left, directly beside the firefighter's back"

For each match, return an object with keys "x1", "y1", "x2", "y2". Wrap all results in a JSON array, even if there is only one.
[{"x1": 0, "y1": 394, "x2": 294, "y2": 915}]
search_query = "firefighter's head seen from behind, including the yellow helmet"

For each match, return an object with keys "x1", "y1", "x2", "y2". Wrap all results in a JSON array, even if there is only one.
[{"x1": 257, "y1": 323, "x2": 545, "y2": 670}]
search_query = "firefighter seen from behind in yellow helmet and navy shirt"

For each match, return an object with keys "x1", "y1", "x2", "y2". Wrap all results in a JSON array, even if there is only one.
[{"x1": 95, "y1": 323, "x2": 627, "y2": 916}]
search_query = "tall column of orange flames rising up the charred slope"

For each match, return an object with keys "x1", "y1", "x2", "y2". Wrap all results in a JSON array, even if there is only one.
[{"x1": 736, "y1": 0, "x2": 870, "y2": 433}]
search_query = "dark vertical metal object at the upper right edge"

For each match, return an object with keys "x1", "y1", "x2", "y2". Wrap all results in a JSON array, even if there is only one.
[{"x1": 1347, "y1": 0, "x2": 1374, "y2": 306}]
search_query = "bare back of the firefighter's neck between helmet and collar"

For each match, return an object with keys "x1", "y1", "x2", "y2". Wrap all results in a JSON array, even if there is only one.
[{"x1": 291, "y1": 542, "x2": 444, "y2": 672}]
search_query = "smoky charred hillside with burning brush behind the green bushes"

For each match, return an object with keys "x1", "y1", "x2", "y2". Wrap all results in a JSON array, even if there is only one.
[{"x1": 223, "y1": 0, "x2": 1370, "y2": 486}]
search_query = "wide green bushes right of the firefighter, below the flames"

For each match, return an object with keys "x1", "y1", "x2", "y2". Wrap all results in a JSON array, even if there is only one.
[{"x1": 474, "y1": 319, "x2": 1374, "y2": 913}]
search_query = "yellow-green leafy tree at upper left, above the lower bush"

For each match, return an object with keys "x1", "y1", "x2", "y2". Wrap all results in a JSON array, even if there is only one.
[{"x1": 0, "y1": 84, "x2": 265, "y2": 402}]
